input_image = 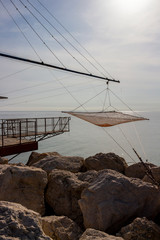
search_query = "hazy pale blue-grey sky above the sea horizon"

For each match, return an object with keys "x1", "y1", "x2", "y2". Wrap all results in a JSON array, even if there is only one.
[{"x1": 0, "y1": 0, "x2": 160, "y2": 111}]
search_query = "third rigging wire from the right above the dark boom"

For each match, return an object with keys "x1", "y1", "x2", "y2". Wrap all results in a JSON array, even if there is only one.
[{"x1": 19, "y1": 0, "x2": 91, "y2": 74}]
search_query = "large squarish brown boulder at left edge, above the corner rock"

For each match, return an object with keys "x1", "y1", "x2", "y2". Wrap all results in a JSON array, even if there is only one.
[{"x1": 0, "y1": 165, "x2": 48, "y2": 215}]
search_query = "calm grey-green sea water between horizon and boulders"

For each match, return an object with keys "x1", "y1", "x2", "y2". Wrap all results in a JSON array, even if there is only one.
[{"x1": 0, "y1": 112, "x2": 160, "y2": 166}]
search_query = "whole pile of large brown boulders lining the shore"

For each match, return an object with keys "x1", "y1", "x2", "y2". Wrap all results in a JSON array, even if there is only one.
[{"x1": 0, "y1": 152, "x2": 160, "y2": 240}]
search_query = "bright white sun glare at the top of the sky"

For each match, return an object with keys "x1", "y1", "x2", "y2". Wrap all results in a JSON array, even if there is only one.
[{"x1": 117, "y1": 0, "x2": 150, "y2": 14}]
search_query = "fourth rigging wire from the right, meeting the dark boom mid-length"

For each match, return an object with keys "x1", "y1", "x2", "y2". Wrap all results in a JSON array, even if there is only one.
[{"x1": 10, "y1": 0, "x2": 66, "y2": 68}]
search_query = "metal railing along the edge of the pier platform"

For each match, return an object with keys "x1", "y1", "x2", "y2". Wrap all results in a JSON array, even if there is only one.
[{"x1": 0, "y1": 117, "x2": 70, "y2": 146}]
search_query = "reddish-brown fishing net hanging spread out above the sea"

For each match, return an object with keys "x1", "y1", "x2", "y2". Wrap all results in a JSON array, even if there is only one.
[{"x1": 62, "y1": 111, "x2": 148, "y2": 127}]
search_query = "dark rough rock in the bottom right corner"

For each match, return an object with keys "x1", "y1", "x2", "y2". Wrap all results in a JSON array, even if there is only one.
[{"x1": 117, "y1": 218, "x2": 160, "y2": 240}]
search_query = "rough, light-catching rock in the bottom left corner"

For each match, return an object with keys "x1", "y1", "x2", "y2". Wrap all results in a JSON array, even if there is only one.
[{"x1": 0, "y1": 201, "x2": 51, "y2": 240}]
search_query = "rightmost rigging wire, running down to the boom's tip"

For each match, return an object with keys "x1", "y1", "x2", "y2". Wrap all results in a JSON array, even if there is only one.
[{"x1": 37, "y1": 0, "x2": 114, "y2": 79}]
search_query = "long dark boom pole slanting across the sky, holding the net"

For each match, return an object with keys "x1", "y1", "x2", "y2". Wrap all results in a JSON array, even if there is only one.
[{"x1": 0, "y1": 53, "x2": 120, "y2": 83}]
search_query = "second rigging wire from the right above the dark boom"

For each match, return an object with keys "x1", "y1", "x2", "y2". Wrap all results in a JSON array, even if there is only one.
[{"x1": 26, "y1": 0, "x2": 109, "y2": 76}]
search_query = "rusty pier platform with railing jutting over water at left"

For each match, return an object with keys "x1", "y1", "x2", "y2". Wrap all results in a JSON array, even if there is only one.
[{"x1": 0, "y1": 117, "x2": 70, "y2": 157}]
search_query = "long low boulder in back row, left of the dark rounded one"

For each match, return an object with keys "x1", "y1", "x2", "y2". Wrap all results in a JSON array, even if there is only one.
[{"x1": 33, "y1": 156, "x2": 84, "y2": 173}]
